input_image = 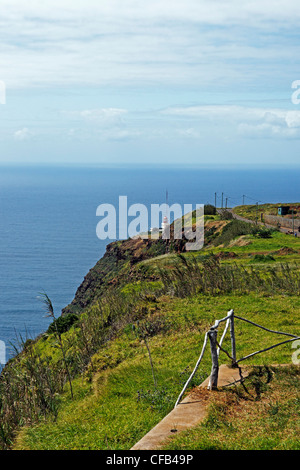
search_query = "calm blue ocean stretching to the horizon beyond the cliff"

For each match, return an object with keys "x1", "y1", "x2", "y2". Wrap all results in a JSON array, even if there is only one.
[{"x1": 0, "y1": 166, "x2": 300, "y2": 357}]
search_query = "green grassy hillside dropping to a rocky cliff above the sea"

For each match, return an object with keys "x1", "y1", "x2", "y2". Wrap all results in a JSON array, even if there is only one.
[{"x1": 0, "y1": 208, "x2": 300, "y2": 450}]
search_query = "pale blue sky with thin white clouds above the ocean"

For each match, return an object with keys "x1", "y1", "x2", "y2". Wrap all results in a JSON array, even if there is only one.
[{"x1": 0, "y1": 0, "x2": 300, "y2": 167}]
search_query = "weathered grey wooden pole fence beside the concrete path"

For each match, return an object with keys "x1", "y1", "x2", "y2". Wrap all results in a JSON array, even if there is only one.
[{"x1": 175, "y1": 310, "x2": 300, "y2": 408}]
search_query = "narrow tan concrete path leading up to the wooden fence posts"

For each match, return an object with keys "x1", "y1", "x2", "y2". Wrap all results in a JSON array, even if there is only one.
[{"x1": 131, "y1": 365, "x2": 248, "y2": 450}]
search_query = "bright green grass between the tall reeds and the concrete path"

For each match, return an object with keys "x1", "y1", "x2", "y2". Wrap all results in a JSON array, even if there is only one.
[{"x1": 14, "y1": 294, "x2": 300, "y2": 450}]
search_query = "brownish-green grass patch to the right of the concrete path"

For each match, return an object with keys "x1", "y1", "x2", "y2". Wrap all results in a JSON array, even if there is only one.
[{"x1": 163, "y1": 366, "x2": 300, "y2": 450}]
